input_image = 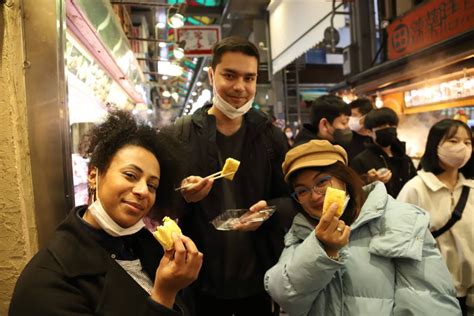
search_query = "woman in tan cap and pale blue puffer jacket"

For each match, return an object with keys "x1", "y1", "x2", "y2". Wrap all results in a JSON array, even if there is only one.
[{"x1": 265, "y1": 140, "x2": 461, "y2": 316}]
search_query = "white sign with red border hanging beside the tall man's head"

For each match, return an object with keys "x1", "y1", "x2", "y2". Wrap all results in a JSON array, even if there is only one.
[{"x1": 175, "y1": 25, "x2": 221, "y2": 57}]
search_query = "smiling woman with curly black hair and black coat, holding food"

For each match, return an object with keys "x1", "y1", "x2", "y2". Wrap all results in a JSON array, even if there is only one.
[{"x1": 9, "y1": 111, "x2": 202, "y2": 316}]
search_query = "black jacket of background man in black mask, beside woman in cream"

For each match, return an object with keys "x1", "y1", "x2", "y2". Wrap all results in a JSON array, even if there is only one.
[{"x1": 349, "y1": 142, "x2": 416, "y2": 198}]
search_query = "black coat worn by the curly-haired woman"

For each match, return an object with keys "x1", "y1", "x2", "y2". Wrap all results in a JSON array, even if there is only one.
[{"x1": 9, "y1": 206, "x2": 190, "y2": 316}]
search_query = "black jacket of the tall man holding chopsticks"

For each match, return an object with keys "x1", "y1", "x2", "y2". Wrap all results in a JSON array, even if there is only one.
[{"x1": 170, "y1": 104, "x2": 295, "y2": 298}]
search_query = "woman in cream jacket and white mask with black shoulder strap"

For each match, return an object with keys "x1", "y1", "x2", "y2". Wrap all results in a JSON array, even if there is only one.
[{"x1": 397, "y1": 119, "x2": 474, "y2": 316}]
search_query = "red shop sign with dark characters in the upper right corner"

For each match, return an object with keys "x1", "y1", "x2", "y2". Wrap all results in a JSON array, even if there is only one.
[{"x1": 387, "y1": 0, "x2": 474, "y2": 60}]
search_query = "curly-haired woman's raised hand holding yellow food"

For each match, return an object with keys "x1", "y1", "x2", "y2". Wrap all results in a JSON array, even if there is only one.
[{"x1": 151, "y1": 233, "x2": 203, "y2": 308}]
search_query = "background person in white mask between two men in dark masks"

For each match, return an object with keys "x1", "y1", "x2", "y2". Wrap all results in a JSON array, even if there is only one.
[{"x1": 347, "y1": 98, "x2": 374, "y2": 161}]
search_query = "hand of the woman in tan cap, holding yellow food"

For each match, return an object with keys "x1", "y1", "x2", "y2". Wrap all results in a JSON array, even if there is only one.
[{"x1": 315, "y1": 203, "x2": 351, "y2": 257}]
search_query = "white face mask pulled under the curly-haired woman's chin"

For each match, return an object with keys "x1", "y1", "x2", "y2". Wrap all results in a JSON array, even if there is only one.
[{"x1": 88, "y1": 169, "x2": 145, "y2": 237}]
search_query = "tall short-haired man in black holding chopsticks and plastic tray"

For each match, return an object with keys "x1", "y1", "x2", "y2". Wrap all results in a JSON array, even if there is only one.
[{"x1": 166, "y1": 37, "x2": 294, "y2": 316}]
